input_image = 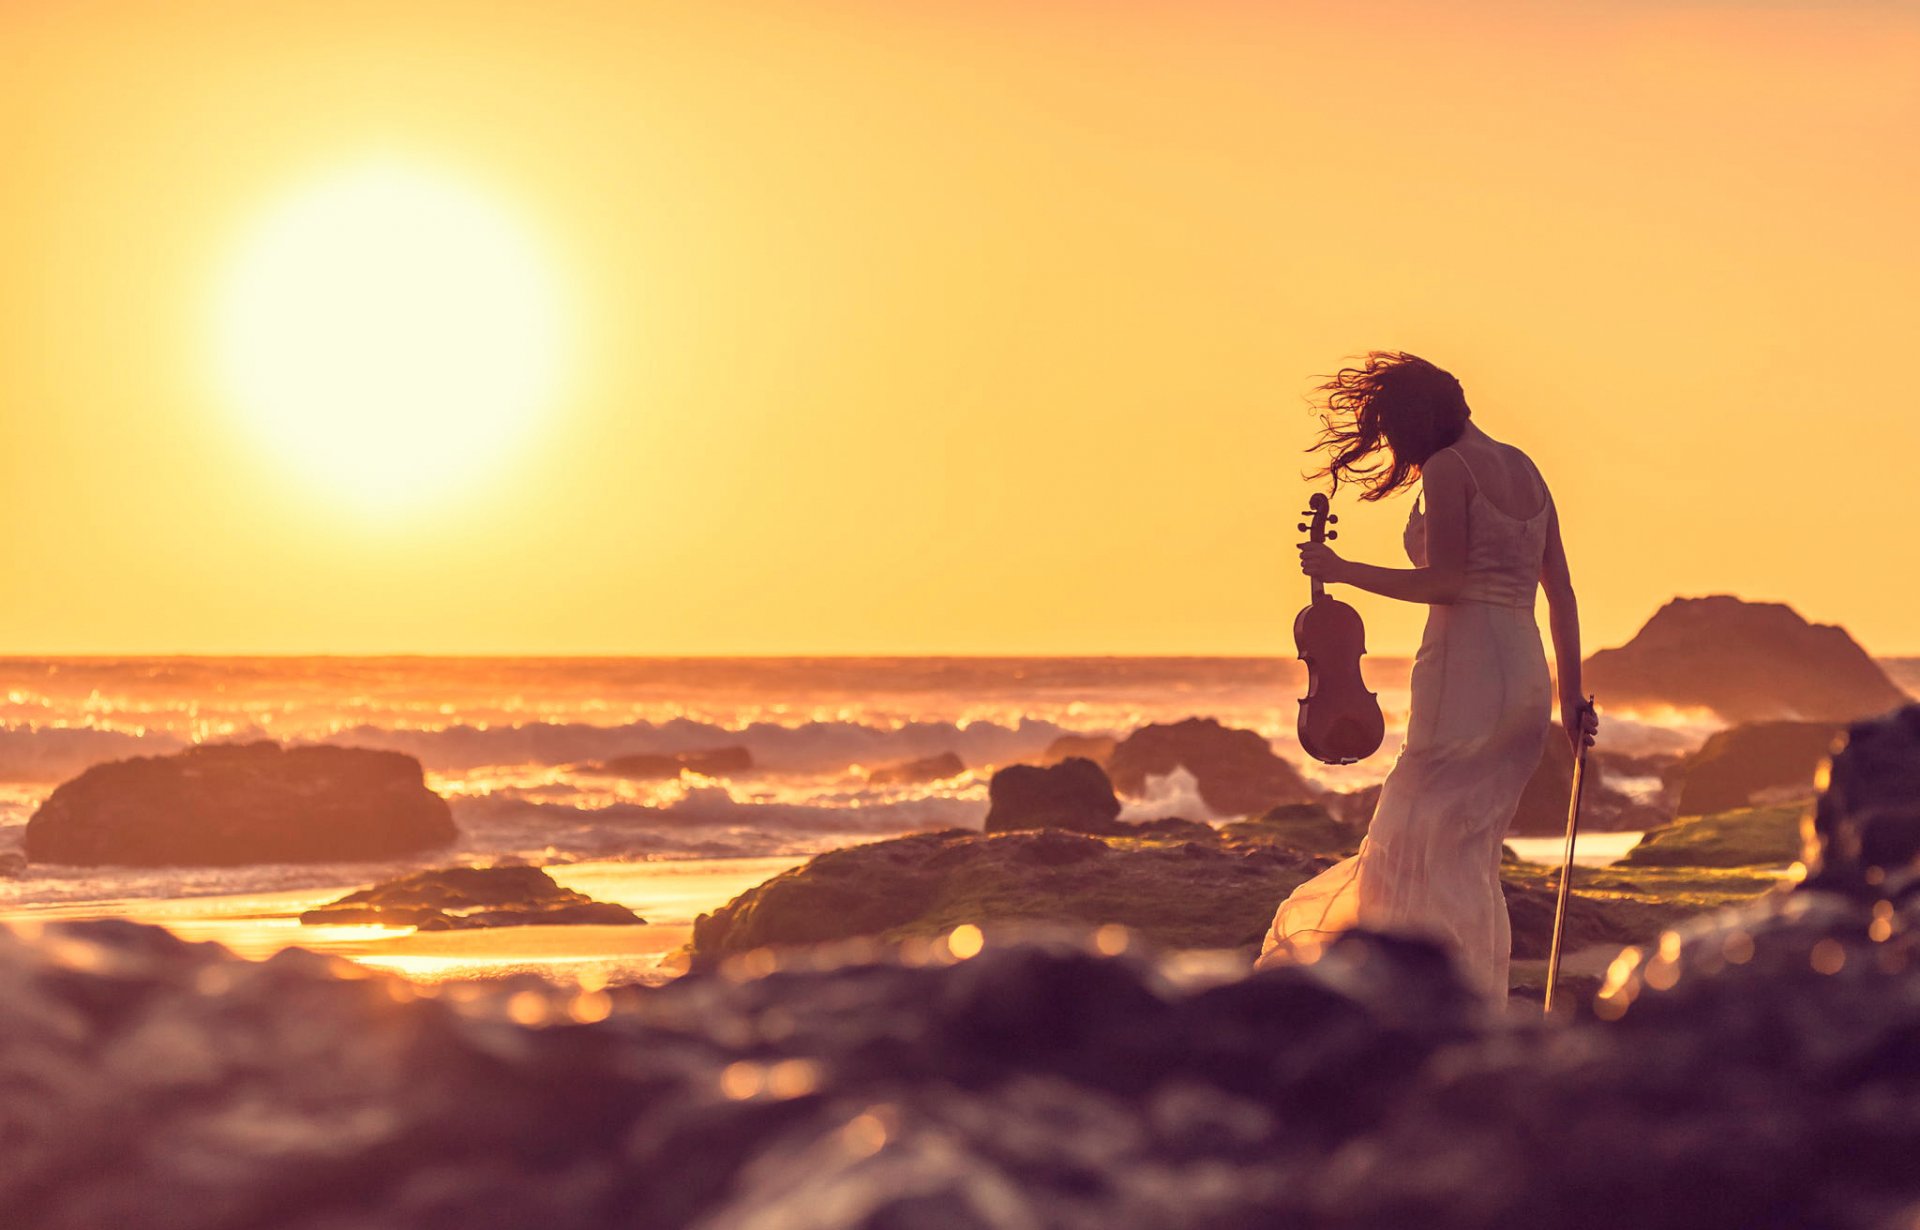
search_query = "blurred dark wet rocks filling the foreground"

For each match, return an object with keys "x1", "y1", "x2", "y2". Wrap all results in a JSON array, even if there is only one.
[{"x1": 0, "y1": 901, "x2": 1920, "y2": 1230}]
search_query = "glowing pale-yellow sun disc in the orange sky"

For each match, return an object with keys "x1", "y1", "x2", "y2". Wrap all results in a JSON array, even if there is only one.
[{"x1": 215, "y1": 163, "x2": 563, "y2": 512}]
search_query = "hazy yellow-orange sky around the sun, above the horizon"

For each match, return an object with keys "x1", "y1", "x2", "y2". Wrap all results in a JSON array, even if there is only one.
[{"x1": 0, "y1": 0, "x2": 1920, "y2": 654}]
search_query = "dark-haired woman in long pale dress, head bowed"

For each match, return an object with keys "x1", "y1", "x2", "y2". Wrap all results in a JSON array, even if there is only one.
[{"x1": 1260, "y1": 351, "x2": 1599, "y2": 1002}]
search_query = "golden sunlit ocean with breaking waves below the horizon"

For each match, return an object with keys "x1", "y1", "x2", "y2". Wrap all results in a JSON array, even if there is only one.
[{"x1": 0, "y1": 656, "x2": 1920, "y2": 906}]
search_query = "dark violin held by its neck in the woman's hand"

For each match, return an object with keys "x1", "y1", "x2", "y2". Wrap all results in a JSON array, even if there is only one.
[{"x1": 1294, "y1": 491, "x2": 1386, "y2": 764}]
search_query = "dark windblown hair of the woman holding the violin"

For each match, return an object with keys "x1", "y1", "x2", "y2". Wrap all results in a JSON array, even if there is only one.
[{"x1": 1308, "y1": 351, "x2": 1473, "y2": 501}]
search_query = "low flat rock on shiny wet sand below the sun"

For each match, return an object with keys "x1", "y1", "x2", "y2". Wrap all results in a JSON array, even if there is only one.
[{"x1": 300, "y1": 865, "x2": 645, "y2": 931}]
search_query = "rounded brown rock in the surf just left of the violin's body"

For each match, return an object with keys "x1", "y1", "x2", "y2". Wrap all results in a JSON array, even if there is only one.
[{"x1": 1108, "y1": 718, "x2": 1313, "y2": 816}]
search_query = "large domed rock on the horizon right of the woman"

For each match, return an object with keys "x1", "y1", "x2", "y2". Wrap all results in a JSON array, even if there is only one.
[{"x1": 1582, "y1": 595, "x2": 1908, "y2": 721}]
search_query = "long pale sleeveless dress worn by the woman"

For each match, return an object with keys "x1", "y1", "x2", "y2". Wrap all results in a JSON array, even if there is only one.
[{"x1": 1258, "y1": 453, "x2": 1553, "y2": 1002}]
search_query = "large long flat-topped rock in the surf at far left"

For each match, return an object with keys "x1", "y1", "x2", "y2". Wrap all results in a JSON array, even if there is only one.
[{"x1": 25, "y1": 743, "x2": 455, "y2": 867}]
